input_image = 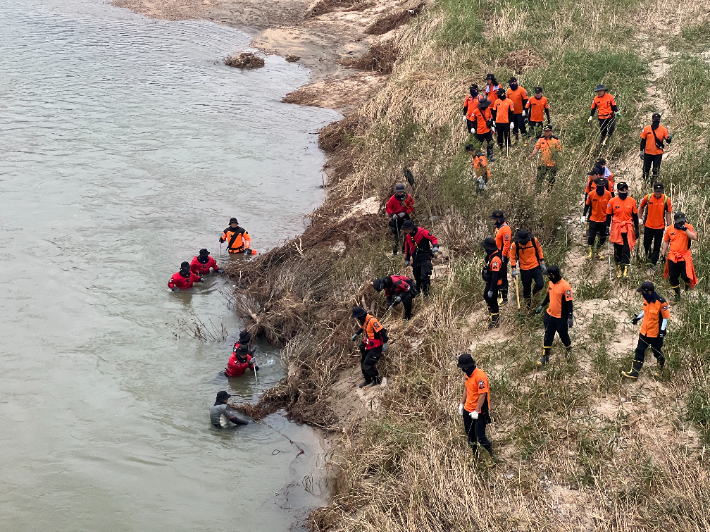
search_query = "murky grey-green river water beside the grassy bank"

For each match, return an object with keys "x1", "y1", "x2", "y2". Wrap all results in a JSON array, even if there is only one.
[{"x1": 0, "y1": 0, "x2": 338, "y2": 532}]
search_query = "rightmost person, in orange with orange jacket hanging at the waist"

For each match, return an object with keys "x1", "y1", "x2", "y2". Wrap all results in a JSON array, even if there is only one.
[{"x1": 661, "y1": 212, "x2": 698, "y2": 301}]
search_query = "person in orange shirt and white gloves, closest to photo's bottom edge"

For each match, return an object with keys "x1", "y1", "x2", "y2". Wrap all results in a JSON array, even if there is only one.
[{"x1": 456, "y1": 353, "x2": 495, "y2": 467}]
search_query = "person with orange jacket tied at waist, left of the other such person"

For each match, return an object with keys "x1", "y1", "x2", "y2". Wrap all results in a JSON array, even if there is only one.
[{"x1": 606, "y1": 181, "x2": 639, "y2": 279}]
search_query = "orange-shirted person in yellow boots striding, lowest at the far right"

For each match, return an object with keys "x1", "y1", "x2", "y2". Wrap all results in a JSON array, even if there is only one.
[{"x1": 621, "y1": 281, "x2": 671, "y2": 379}]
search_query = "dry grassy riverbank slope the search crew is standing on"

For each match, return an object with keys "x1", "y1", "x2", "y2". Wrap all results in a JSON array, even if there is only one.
[{"x1": 229, "y1": 0, "x2": 710, "y2": 531}]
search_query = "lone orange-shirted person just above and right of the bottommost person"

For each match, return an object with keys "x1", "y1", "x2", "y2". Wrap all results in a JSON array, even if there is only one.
[{"x1": 535, "y1": 265, "x2": 574, "y2": 366}]
